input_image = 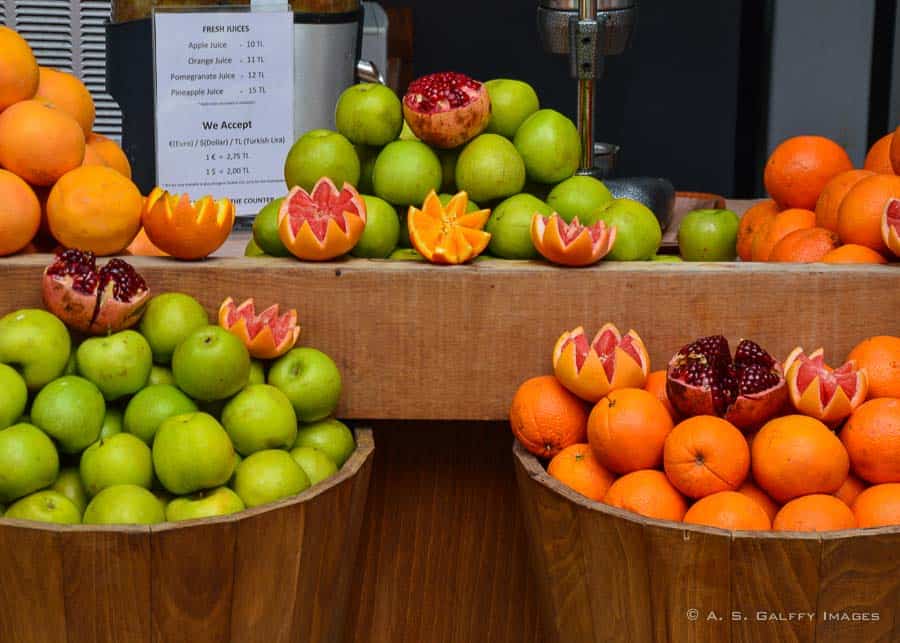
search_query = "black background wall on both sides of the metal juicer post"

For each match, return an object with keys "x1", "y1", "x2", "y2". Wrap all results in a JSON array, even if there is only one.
[{"x1": 381, "y1": 0, "x2": 752, "y2": 195}]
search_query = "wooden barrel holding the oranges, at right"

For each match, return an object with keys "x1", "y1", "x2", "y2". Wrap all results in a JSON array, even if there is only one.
[{"x1": 513, "y1": 442, "x2": 900, "y2": 643}]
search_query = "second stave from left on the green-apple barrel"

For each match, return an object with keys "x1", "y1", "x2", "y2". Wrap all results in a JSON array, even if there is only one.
[{"x1": 60, "y1": 526, "x2": 152, "y2": 643}]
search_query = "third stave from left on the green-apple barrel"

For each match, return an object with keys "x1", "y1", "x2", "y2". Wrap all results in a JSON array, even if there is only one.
[{"x1": 151, "y1": 519, "x2": 236, "y2": 643}]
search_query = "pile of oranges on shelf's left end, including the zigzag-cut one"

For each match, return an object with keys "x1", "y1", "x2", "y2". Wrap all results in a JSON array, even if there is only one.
[{"x1": 0, "y1": 26, "x2": 234, "y2": 259}]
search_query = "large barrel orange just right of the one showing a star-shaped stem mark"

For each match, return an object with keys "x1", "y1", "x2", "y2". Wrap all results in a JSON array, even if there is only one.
[{"x1": 750, "y1": 415, "x2": 850, "y2": 504}]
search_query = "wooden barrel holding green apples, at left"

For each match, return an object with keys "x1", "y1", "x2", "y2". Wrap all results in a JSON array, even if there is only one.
[{"x1": 0, "y1": 430, "x2": 374, "y2": 643}]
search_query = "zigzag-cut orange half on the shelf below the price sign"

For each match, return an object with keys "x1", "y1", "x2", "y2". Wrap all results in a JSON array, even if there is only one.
[{"x1": 141, "y1": 187, "x2": 234, "y2": 259}]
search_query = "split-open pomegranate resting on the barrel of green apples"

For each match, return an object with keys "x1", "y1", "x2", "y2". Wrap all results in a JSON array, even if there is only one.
[{"x1": 42, "y1": 249, "x2": 150, "y2": 335}]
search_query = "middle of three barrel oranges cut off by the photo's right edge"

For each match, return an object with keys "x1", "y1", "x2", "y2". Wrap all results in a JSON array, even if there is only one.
[{"x1": 841, "y1": 397, "x2": 900, "y2": 484}]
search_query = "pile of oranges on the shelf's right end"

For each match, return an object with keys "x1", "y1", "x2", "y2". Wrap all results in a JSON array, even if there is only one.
[{"x1": 737, "y1": 128, "x2": 900, "y2": 264}]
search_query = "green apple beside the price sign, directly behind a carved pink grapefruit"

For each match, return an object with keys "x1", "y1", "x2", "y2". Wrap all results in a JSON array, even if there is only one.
[{"x1": 284, "y1": 129, "x2": 359, "y2": 192}]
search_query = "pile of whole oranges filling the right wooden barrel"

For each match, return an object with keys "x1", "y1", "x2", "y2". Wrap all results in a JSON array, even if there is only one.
[{"x1": 510, "y1": 336, "x2": 900, "y2": 531}]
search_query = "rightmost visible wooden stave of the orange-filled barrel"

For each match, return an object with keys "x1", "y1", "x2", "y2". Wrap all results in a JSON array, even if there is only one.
[{"x1": 816, "y1": 527, "x2": 900, "y2": 643}]
